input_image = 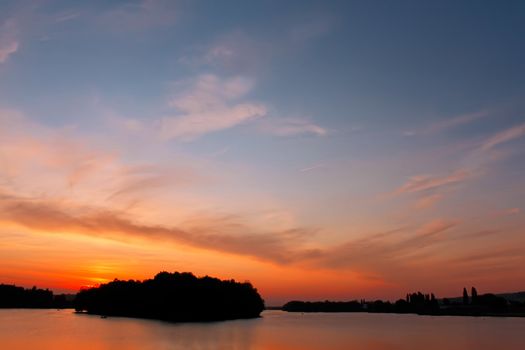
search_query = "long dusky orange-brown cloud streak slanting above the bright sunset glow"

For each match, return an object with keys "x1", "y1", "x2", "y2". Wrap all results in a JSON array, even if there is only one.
[{"x1": 0, "y1": 194, "x2": 314, "y2": 264}]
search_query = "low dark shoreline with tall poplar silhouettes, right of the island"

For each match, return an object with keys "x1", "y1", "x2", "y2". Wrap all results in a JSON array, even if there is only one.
[{"x1": 282, "y1": 288, "x2": 525, "y2": 317}]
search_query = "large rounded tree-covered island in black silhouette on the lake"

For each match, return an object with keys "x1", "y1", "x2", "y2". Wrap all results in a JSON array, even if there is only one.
[{"x1": 75, "y1": 272, "x2": 264, "y2": 322}]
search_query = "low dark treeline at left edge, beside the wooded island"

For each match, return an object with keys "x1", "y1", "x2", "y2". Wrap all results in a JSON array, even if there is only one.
[{"x1": 0, "y1": 284, "x2": 73, "y2": 309}]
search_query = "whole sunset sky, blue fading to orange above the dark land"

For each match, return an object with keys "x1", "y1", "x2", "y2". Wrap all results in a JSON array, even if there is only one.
[{"x1": 0, "y1": 0, "x2": 525, "y2": 305}]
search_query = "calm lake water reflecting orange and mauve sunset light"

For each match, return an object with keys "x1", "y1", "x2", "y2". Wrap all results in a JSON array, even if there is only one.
[{"x1": 0, "y1": 310, "x2": 525, "y2": 350}]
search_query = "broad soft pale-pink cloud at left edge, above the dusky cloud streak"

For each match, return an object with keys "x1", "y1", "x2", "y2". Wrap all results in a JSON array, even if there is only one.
[{"x1": 0, "y1": 110, "x2": 201, "y2": 206}]
